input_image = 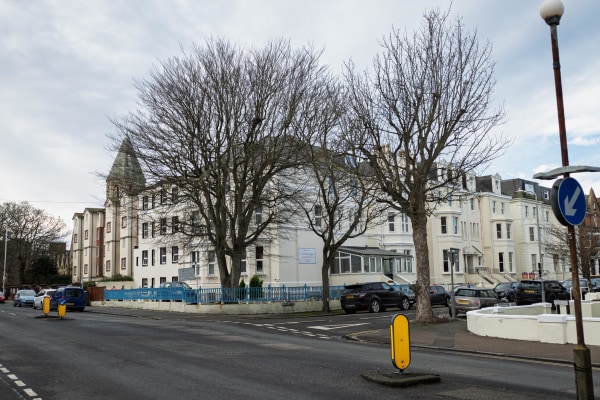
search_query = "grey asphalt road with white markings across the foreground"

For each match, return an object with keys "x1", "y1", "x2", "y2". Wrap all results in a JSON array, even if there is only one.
[{"x1": 0, "y1": 304, "x2": 600, "y2": 400}]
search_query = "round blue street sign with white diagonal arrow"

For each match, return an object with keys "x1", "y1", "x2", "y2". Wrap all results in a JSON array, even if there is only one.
[{"x1": 550, "y1": 177, "x2": 586, "y2": 226}]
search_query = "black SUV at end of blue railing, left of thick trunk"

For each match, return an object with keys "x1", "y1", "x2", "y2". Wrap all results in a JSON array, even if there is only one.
[{"x1": 340, "y1": 282, "x2": 410, "y2": 314}]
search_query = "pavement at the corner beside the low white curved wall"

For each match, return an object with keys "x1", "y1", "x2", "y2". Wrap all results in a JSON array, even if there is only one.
[{"x1": 348, "y1": 317, "x2": 600, "y2": 368}]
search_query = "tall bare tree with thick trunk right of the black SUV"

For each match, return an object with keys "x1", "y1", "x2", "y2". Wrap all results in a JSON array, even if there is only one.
[{"x1": 345, "y1": 10, "x2": 509, "y2": 322}]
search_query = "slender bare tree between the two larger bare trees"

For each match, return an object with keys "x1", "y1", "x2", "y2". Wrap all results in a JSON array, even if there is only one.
[{"x1": 295, "y1": 80, "x2": 387, "y2": 312}]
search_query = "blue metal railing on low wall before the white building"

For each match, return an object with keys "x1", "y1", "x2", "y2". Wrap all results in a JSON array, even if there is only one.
[{"x1": 104, "y1": 285, "x2": 344, "y2": 304}]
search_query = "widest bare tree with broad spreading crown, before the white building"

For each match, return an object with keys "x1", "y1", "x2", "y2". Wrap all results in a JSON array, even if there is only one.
[{"x1": 110, "y1": 39, "x2": 327, "y2": 287}]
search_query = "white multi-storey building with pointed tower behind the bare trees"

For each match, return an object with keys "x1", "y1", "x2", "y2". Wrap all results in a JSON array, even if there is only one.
[{"x1": 71, "y1": 139, "x2": 568, "y2": 288}]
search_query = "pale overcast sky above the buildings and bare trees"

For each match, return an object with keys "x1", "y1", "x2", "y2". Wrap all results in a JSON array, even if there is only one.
[{"x1": 0, "y1": 0, "x2": 600, "y2": 229}]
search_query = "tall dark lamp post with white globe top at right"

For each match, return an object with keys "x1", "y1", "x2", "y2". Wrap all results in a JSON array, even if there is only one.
[{"x1": 540, "y1": 0, "x2": 594, "y2": 399}]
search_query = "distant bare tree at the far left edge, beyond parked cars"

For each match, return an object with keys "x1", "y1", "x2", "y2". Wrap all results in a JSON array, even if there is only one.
[{"x1": 0, "y1": 202, "x2": 67, "y2": 285}]
